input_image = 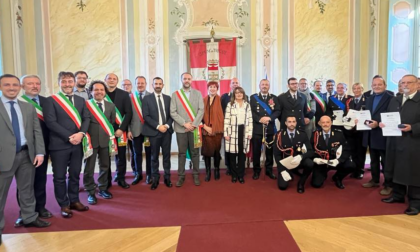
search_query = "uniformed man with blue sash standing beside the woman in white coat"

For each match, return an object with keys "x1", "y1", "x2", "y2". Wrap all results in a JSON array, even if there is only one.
[{"x1": 251, "y1": 79, "x2": 280, "y2": 180}]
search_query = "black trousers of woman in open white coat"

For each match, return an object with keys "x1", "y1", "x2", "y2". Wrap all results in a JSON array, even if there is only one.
[{"x1": 229, "y1": 125, "x2": 246, "y2": 178}]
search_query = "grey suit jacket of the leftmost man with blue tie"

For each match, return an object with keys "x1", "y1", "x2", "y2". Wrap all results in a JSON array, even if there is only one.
[{"x1": 0, "y1": 101, "x2": 45, "y2": 172}]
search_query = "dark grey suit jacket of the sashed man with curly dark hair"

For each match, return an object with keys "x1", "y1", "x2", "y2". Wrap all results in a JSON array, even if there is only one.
[{"x1": 88, "y1": 101, "x2": 116, "y2": 148}]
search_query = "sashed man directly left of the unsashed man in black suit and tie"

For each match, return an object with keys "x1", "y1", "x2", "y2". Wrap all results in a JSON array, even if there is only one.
[{"x1": 127, "y1": 76, "x2": 152, "y2": 185}]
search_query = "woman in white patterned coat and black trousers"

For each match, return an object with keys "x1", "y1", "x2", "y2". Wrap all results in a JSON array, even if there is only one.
[{"x1": 224, "y1": 87, "x2": 252, "y2": 184}]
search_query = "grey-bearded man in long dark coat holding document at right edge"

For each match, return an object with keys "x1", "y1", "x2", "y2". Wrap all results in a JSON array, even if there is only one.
[{"x1": 380, "y1": 75, "x2": 420, "y2": 215}]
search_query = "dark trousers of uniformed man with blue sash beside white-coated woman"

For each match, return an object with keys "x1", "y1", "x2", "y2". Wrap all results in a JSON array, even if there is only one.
[{"x1": 251, "y1": 135, "x2": 273, "y2": 173}]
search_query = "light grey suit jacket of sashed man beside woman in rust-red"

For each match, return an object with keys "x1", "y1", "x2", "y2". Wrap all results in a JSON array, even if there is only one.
[{"x1": 171, "y1": 88, "x2": 204, "y2": 133}]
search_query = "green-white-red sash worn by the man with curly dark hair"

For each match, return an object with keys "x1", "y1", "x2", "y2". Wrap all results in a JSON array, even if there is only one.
[{"x1": 86, "y1": 99, "x2": 118, "y2": 156}]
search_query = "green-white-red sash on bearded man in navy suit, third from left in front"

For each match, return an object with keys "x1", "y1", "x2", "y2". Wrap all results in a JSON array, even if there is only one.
[{"x1": 51, "y1": 92, "x2": 93, "y2": 158}]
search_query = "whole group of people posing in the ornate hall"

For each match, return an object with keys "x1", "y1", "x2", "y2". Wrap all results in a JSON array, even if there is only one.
[{"x1": 0, "y1": 71, "x2": 420, "y2": 244}]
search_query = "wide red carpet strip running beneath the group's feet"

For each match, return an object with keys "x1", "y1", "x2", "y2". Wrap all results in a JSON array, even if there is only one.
[{"x1": 4, "y1": 170, "x2": 406, "y2": 234}]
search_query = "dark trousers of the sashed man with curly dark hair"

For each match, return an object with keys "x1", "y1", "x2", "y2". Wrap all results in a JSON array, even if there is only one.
[{"x1": 83, "y1": 147, "x2": 111, "y2": 193}]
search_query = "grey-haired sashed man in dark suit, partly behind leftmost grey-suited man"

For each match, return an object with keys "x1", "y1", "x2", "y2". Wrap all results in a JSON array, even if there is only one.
[{"x1": 15, "y1": 75, "x2": 52, "y2": 227}]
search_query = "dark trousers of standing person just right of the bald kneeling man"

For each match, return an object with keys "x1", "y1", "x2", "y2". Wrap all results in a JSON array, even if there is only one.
[{"x1": 346, "y1": 132, "x2": 367, "y2": 174}]
